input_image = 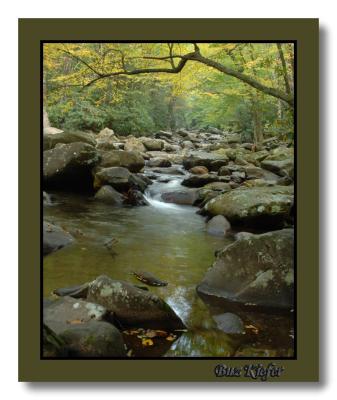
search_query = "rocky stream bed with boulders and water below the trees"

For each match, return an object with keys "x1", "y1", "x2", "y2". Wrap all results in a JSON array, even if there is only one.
[{"x1": 43, "y1": 128, "x2": 294, "y2": 358}]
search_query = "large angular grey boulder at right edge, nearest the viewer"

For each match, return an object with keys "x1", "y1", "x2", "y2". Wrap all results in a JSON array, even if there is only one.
[{"x1": 197, "y1": 229, "x2": 294, "y2": 309}]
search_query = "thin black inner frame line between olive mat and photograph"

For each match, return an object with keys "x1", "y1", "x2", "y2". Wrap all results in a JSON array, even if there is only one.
[{"x1": 40, "y1": 39, "x2": 298, "y2": 361}]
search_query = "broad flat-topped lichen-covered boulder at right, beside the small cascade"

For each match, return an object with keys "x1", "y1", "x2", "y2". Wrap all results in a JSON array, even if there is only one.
[{"x1": 203, "y1": 186, "x2": 294, "y2": 226}]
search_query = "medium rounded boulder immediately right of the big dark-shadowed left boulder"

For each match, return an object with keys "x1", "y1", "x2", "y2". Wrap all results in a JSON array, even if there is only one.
[{"x1": 99, "y1": 150, "x2": 145, "y2": 172}]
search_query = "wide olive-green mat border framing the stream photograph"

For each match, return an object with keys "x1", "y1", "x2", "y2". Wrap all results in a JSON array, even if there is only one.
[{"x1": 19, "y1": 19, "x2": 319, "y2": 382}]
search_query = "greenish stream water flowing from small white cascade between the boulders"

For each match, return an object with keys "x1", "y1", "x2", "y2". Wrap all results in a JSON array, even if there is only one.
[{"x1": 43, "y1": 167, "x2": 293, "y2": 357}]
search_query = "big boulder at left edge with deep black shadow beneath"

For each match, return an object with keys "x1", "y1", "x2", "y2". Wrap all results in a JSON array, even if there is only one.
[{"x1": 43, "y1": 142, "x2": 99, "y2": 190}]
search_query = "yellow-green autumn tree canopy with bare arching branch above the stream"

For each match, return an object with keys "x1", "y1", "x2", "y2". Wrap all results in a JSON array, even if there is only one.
[{"x1": 44, "y1": 43, "x2": 294, "y2": 141}]
